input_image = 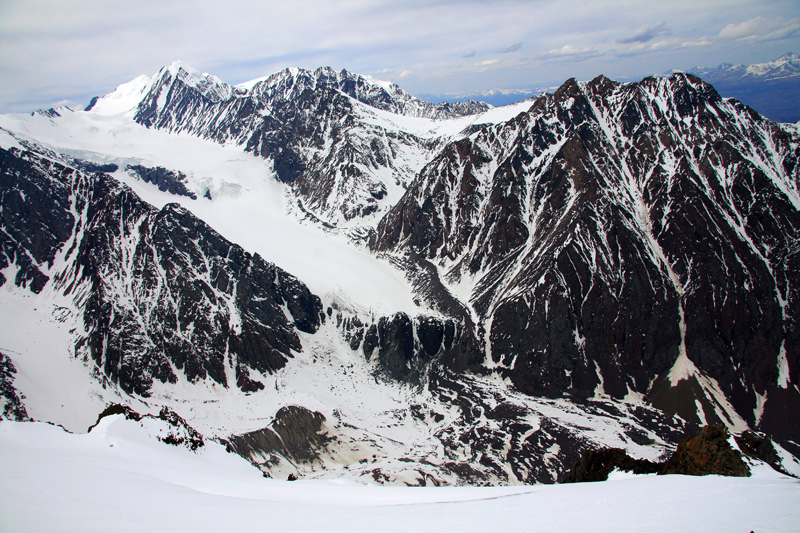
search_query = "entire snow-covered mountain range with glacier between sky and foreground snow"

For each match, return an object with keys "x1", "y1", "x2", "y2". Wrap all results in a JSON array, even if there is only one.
[{"x1": 0, "y1": 62, "x2": 800, "y2": 485}]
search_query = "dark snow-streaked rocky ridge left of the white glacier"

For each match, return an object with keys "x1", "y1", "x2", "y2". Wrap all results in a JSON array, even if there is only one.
[{"x1": 0, "y1": 145, "x2": 324, "y2": 396}]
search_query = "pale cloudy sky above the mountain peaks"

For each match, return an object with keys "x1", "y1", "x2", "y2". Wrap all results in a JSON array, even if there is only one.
[{"x1": 0, "y1": 0, "x2": 800, "y2": 113}]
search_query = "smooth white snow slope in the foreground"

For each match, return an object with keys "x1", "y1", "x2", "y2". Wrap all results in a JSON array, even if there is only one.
[{"x1": 0, "y1": 416, "x2": 800, "y2": 532}]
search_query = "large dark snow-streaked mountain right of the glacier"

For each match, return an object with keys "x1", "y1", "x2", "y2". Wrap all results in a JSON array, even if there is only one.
[{"x1": 371, "y1": 75, "x2": 800, "y2": 440}]
